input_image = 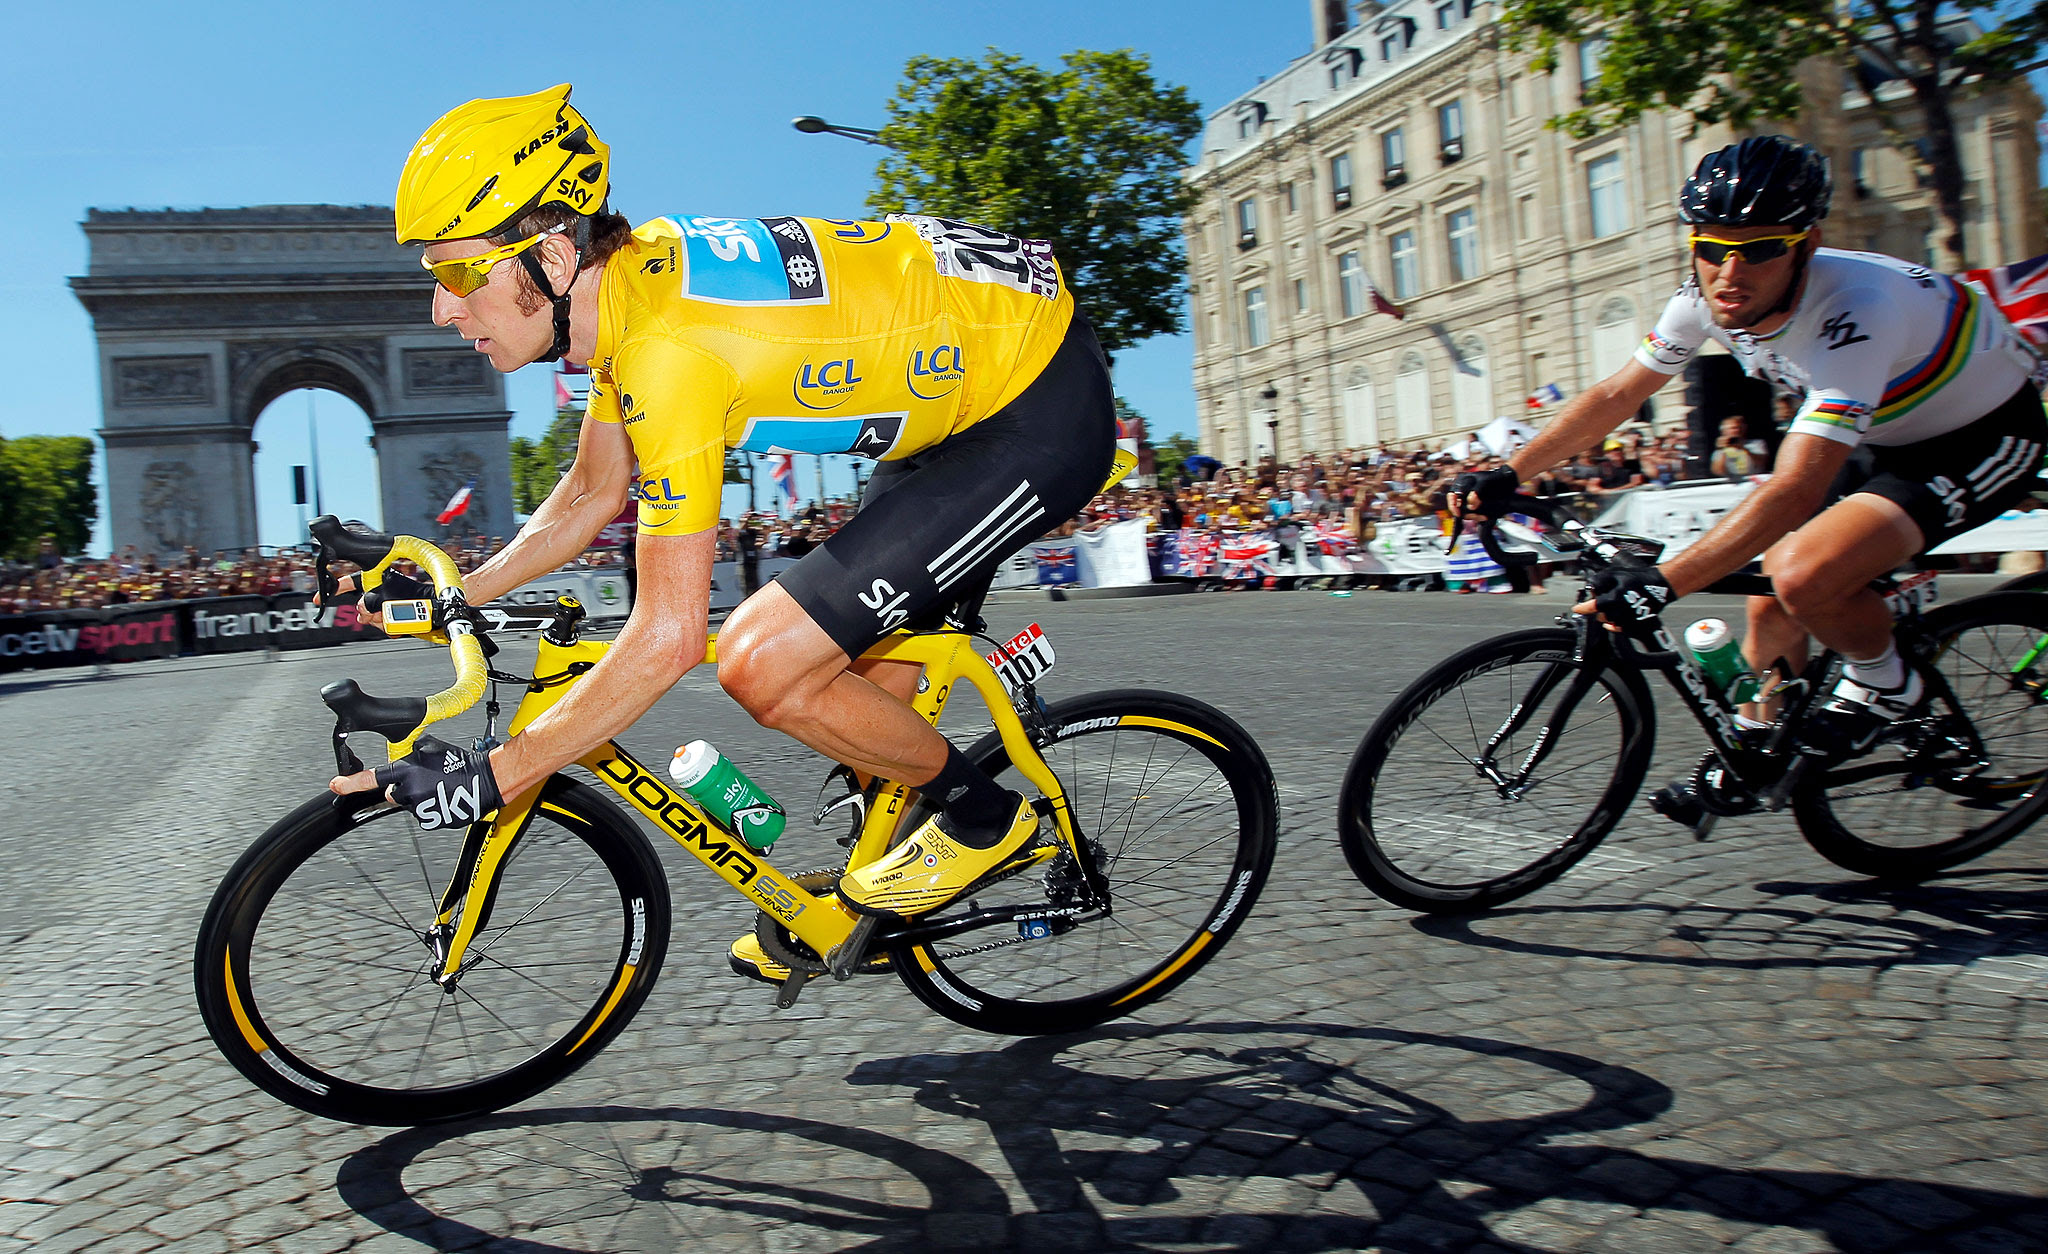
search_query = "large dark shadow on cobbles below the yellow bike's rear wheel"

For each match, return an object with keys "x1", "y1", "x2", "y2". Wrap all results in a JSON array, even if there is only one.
[{"x1": 848, "y1": 1022, "x2": 2048, "y2": 1252}]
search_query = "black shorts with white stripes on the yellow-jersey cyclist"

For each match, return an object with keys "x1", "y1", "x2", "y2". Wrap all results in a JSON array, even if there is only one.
[{"x1": 778, "y1": 309, "x2": 1116, "y2": 658}]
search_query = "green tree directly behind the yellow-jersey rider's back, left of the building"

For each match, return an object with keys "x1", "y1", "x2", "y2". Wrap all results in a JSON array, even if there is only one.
[{"x1": 868, "y1": 49, "x2": 1202, "y2": 352}]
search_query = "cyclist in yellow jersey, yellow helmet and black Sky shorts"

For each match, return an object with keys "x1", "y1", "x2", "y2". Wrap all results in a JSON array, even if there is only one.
[{"x1": 332, "y1": 84, "x2": 1116, "y2": 954}]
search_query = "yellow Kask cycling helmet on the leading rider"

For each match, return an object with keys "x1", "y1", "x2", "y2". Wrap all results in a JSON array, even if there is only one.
[{"x1": 397, "y1": 82, "x2": 612, "y2": 244}]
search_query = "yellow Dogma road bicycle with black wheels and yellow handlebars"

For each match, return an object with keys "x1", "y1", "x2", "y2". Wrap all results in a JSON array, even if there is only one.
[{"x1": 195, "y1": 516, "x2": 1278, "y2": 1125}]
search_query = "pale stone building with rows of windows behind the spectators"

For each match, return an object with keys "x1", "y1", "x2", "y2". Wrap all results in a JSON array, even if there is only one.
[{"x1": 1184, "y1": 0, "x2": 2042, "y2": 461}]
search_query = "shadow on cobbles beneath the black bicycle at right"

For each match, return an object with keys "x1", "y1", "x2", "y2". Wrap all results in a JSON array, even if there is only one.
[{"x1": 1409, "y1": 869, "x2": 2048, "y2": 971}]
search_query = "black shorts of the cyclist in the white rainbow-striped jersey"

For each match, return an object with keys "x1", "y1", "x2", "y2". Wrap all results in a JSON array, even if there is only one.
[{"x1": 1845, "y1": 383, "x2": 2048, "y2": 553}]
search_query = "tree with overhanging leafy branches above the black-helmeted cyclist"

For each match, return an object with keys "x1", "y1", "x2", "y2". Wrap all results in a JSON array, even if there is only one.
[{"x1": 1505, "y1": 0, "x2": 2048, "y2": 270}]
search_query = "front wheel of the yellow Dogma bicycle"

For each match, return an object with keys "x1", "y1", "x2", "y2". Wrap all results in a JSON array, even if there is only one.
[{"x1": 193, "y1": 775, "x2": 670, "y2": 1125}]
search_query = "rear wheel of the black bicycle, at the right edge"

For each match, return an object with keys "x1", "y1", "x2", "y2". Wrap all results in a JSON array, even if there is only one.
[{"x1": 1792, "y1": 592, "x2": 2048, "y2": 879}]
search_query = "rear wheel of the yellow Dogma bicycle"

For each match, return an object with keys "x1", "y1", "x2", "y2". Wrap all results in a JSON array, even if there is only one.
[{"x1": 891, "y1": 688, "x2": 1278, "y2": 1037}]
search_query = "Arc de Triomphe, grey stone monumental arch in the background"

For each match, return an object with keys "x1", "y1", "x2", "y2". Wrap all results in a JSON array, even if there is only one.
[{"x1": 72, "y1": 205, "x2": 512, "y2": 553}]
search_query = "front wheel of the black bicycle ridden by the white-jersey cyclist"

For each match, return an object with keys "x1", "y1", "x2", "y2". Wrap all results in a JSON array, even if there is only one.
[{"x1": 1337, "y1": 627, "x2": 1655, "y2": 914}]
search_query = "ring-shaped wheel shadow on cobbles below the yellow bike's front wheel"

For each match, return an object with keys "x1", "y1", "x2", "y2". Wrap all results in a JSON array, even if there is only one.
[{"x1": 334, "y1": 1106, "x2": 1010, "y2": 1254}]
